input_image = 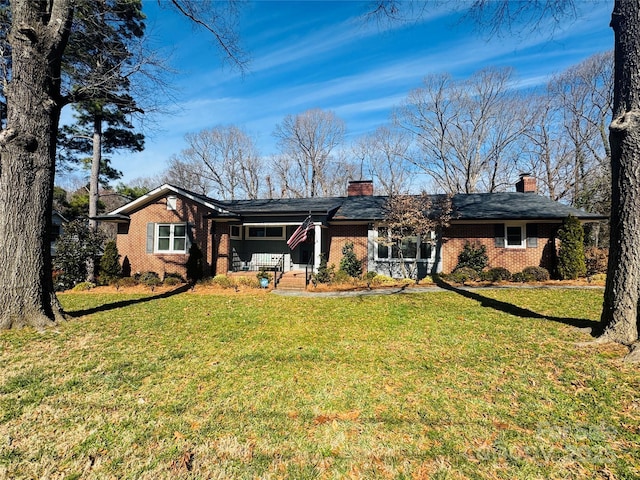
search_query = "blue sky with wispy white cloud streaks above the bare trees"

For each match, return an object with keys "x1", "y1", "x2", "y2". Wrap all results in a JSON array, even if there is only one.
[{"x1": 63, "y1": 0, "x2": 613, "y2": 188}]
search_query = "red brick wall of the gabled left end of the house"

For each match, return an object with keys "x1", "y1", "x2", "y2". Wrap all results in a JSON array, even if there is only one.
[{"x1": 117, "y1": 196, "x2": 212, "y2": 278}]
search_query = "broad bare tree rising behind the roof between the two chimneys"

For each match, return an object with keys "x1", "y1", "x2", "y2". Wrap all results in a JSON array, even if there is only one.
[{"x1": 396, "y1": 69, "x2": 530, "y2": 193}]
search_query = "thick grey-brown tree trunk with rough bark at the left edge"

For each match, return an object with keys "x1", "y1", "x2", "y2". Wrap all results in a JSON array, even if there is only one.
[{"x1": 0, "y1": 0, "x2": 72, "y2": 329}]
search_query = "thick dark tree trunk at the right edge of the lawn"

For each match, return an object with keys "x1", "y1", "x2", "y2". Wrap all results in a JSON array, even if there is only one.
[{"x1": 601, "y1": 0, "x2": 640, "y2": 345}]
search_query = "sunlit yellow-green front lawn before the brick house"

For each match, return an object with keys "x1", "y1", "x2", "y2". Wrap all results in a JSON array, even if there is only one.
[{"x1": 0, "y1": 289, "x2": 640, "y2": 479}]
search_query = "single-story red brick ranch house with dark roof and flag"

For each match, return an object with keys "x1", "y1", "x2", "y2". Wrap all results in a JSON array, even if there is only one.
[{"x1": 100, "y1": 176, "x2": 604, "y2": 277}]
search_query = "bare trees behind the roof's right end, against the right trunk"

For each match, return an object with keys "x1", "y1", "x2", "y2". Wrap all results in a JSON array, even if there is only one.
[{"x1": 523, "y1": 53, "x2": 613, "y2": 213}]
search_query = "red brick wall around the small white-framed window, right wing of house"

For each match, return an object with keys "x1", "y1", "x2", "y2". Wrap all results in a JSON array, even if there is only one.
[{"x1": 442, "y1": 223, "x2": 560, "y2": 273}]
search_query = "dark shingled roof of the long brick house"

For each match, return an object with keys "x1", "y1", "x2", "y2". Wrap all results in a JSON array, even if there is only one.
[{"x1": 101, "y1": 184, "x2": 607, "y2": 222}]
